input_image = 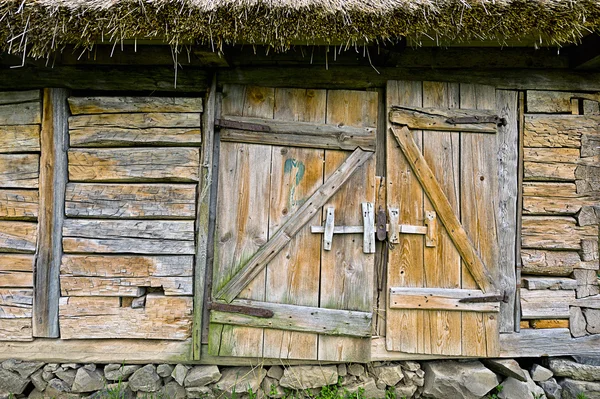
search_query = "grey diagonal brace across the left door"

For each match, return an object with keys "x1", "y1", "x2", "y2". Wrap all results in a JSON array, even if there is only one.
[{"x1": 216, "y1": 149, "x2": 373, "y2": 302}]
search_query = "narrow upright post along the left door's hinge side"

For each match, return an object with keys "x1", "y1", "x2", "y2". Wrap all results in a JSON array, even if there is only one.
[{"x1": 192, "y1": 74, "x2": 217, "y2": 360}]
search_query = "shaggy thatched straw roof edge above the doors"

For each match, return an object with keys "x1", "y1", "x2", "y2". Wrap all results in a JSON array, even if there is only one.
[{"x1": 0, "y1": 0, "x2": 600, "y2": 56}]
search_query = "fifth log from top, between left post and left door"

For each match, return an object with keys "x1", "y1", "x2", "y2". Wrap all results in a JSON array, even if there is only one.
[{"x1": 65, "y1": 183, "x2": 196, "y2": 219}]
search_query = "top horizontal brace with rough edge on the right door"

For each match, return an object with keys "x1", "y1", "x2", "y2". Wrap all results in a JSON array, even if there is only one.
[{"x1": 389, "y1": 102, "x2": 500, "y2": 133}]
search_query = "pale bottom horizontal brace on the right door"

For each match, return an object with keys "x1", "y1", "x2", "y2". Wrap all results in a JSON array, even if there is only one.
[{"x1": 389, "y1": 287, "x2": 500, "y2": 312}]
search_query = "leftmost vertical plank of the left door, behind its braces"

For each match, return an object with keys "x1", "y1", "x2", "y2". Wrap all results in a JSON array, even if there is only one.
[{"x1": 209, "y1": 86, "x2": 274, "y2": 357}]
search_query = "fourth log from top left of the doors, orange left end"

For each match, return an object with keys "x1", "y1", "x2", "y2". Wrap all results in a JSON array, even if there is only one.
[{"x1": 69, "y1": 148, "x2": 200, "y2": 182}]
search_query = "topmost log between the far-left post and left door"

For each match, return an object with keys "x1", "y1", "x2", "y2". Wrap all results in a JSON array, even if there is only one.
[{"x1": 69, "y1": 96, "x2": 202, "y2": 115}]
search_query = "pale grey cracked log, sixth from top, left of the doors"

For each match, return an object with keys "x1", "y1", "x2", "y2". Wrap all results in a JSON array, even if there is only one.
[{"x1": 63, "y1": 219, "x2": 194, "y2": 255}]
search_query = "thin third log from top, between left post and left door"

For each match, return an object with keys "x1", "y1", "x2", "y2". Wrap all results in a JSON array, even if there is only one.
[{"x1": 69, "y1": 126, "x2": 202, "y2": 147}]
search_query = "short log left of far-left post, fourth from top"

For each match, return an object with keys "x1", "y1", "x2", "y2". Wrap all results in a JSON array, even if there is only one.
[{"x1": 0, "y1": 154, "x2": 40, "y2": 188}]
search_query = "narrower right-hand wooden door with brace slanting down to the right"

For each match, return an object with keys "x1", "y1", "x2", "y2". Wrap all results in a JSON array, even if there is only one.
[{"x1": 386, "y1": 82, "x2": 517, "y2": 357}]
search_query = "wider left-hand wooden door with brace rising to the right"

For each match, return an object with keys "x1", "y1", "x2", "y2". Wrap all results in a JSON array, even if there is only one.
[{"x1": 209, "y1": 85, "x2": 378, "y2": 361}]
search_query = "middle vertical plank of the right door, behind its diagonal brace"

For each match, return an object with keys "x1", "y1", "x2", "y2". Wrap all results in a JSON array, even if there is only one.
[{"x1": 419, "y1": 82, "x2": 461, "y2": 355}]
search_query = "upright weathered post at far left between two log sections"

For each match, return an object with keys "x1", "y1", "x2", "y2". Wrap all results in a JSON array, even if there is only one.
[{"x1": 33, "y1": 89, "x2": 69, "y2": 338}]
